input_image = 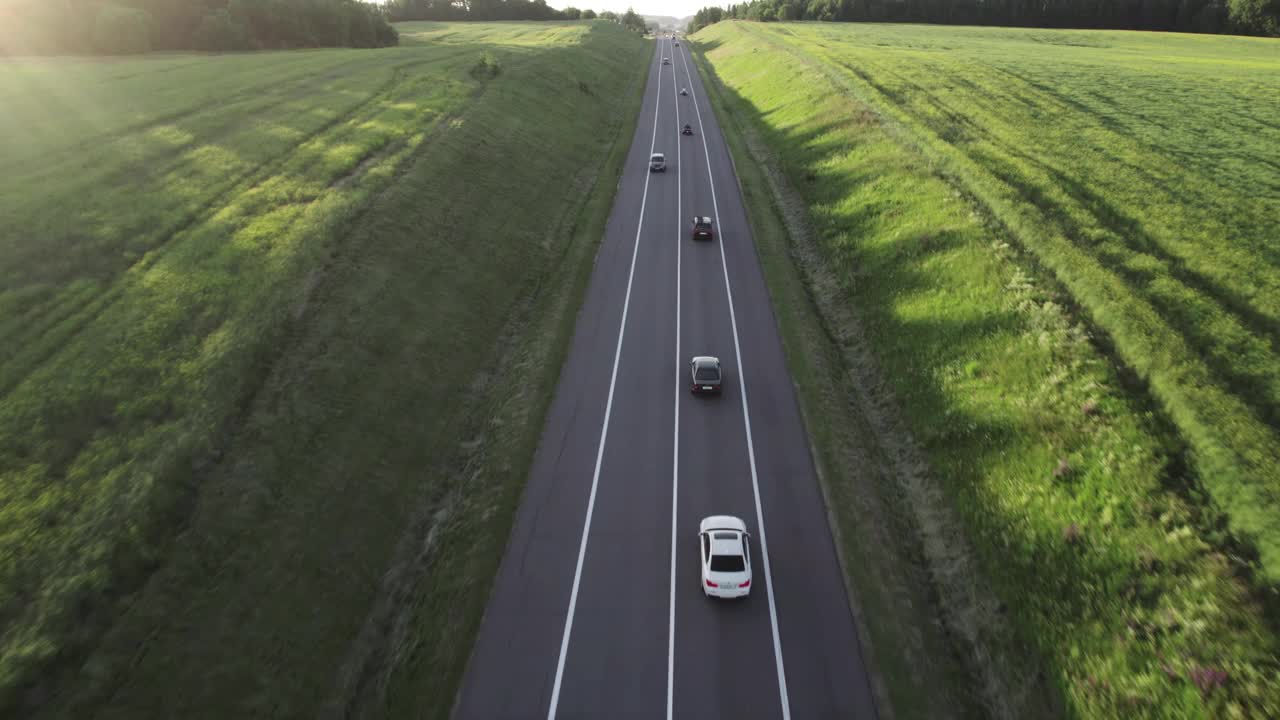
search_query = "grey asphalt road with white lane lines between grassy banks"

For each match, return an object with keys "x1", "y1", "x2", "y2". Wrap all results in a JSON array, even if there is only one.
[{"x1": 453, "y1": 38, "x2": 876, "y2": 720}]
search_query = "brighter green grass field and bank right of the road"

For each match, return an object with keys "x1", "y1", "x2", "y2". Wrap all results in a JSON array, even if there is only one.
[{"x1": 695, "y1": 23, "x2": 1280, "y2": 717}]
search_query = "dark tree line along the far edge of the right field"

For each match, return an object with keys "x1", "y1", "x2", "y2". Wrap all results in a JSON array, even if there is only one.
[{"x1": 689, "y1": 0, "x2": 1280, "y2": 36}]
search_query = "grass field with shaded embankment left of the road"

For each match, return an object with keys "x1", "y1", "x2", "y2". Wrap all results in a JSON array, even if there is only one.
[{"x1": 0, "y1": 23, "x2": 652, "y2": 717}]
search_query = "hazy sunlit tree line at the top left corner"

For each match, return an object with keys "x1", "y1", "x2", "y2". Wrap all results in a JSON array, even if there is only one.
[{"x1": 0, "y1": 0, "x2": 399, "y2": 55}]
